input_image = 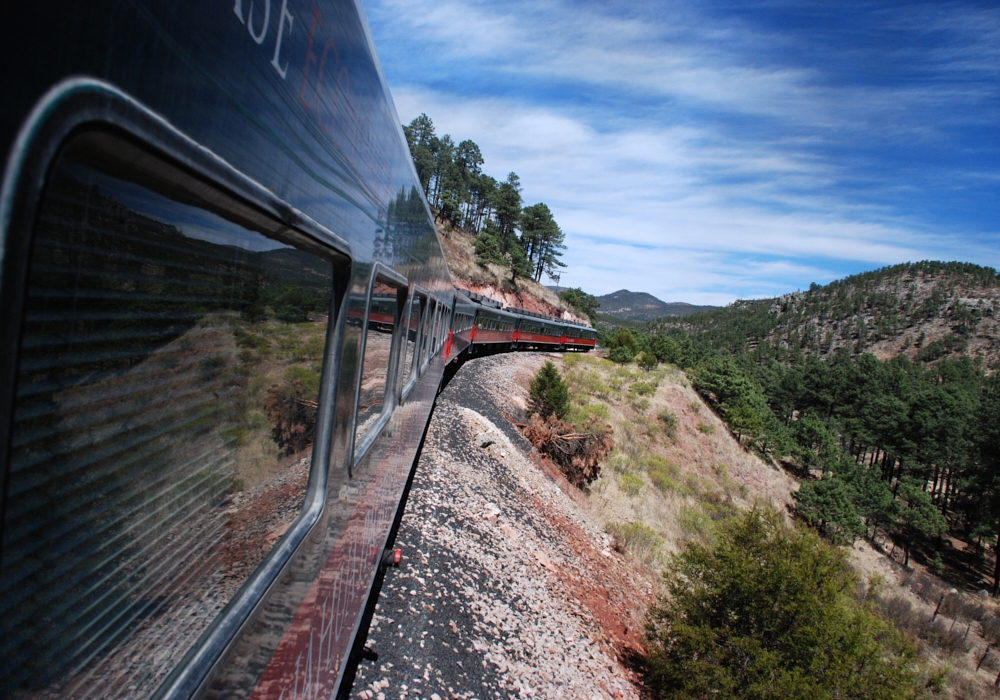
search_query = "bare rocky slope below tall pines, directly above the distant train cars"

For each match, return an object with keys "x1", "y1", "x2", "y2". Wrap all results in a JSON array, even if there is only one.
[{"x1": 437, "y1": 223, "x2": 590, "y2": 326}]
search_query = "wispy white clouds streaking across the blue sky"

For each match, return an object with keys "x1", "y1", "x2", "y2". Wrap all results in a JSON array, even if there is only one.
[{"x1": 375, "y1": 0, "x2": 1000, "y2": 303}]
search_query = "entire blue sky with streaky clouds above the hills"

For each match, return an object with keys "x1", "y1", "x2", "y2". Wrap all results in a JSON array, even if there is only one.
[{"x1": 365, "y1": 0, "x2": 1000, "y2": 304}]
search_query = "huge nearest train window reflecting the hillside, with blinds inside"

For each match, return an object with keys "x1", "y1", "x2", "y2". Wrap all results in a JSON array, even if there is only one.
[{"x1": 0, "y1": 130, "x2": 338, "y2": 697}]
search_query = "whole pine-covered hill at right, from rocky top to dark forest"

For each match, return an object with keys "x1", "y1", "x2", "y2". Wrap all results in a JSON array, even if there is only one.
[{"x1": 602, "y1": 262, "x2": 1000, "y2": 595}]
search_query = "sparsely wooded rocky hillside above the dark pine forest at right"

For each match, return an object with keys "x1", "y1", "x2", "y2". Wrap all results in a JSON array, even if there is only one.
[{"x1": 649, "y1": 261, "x2": 1000, "y2": 369}]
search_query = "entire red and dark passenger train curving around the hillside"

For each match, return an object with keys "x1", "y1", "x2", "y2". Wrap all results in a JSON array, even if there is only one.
[{"x1": 0, "y1": 0, "x2": 595, "y2": 700}]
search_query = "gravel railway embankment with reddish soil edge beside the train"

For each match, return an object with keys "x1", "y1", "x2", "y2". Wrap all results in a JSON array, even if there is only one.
[{"x1": 353, "y1": 354, "x2": 656, "y2": 700}]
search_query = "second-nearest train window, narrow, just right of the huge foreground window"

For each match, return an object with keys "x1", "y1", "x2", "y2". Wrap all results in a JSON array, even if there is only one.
[{"x1": 354, "y1": 273, "x2": 405, "y2": 452}]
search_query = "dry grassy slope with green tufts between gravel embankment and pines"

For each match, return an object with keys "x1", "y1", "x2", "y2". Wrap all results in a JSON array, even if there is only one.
[{"x1": 562, "y1": 355, "x2": 796, "y2": 576}]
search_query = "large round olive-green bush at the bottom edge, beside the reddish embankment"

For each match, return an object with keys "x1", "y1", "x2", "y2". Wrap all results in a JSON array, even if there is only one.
[{"x1": 646, "y1": 508, "x2": 923, "y2": 700}]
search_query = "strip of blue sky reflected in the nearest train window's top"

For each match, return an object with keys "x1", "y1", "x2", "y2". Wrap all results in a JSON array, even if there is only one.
[{"x1": 64, "y1": 163, "x2": 291, "y2": 252}]
